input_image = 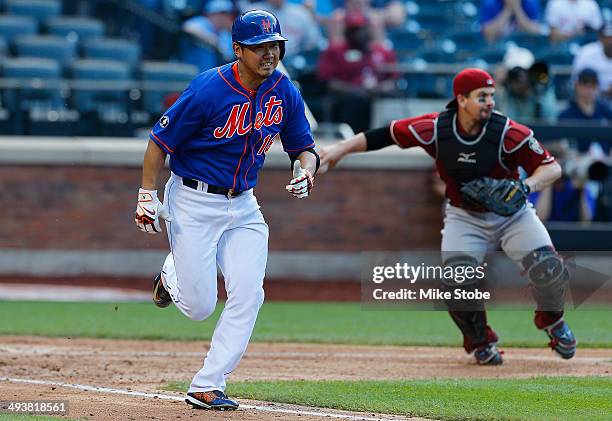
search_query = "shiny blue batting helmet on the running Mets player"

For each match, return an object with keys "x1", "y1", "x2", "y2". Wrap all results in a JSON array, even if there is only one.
[{"x1": 232, "y1": 10, "x2": 287, "y2": 59}]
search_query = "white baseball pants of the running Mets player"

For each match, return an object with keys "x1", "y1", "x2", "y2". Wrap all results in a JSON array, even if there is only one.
[{"x1": 162, "y1": 174, "x2": 268, "y2": 392}]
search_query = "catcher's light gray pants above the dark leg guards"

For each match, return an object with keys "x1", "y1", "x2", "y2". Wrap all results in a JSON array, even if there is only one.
[{"x1": 442, "y1": 202, "x2": 552, "y2": 269}]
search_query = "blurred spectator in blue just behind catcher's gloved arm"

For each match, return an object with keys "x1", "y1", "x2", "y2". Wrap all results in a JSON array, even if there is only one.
[{"x1": 529, "y1": 142, "x2": 595, "y2": 222}]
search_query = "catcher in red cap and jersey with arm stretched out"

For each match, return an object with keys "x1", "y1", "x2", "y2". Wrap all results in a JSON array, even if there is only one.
[{"x1": 319, "y1": 68, "x2": 576, "y2": 365}]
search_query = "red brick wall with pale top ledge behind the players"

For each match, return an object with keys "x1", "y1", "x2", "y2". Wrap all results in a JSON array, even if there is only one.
[{"x1": 0, "y1": 137, "x2": 442, "y2": 296}]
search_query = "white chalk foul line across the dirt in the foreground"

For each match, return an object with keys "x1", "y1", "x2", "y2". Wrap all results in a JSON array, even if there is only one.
[{"x1": 0, "y1": 377, "x2": 412, "y2": 421}]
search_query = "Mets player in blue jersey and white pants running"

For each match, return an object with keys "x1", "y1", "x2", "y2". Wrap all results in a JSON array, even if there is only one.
[{"x1": 135, "y1": 10, "x2": 319, "y2": 410}]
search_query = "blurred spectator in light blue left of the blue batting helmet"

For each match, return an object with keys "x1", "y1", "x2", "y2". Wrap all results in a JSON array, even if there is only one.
[{"x1": 181, "y1": 0, "x2": 236, "y2": 71}]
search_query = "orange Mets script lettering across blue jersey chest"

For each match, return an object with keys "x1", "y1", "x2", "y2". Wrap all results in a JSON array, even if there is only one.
[{"x1": 213, "y1": 96, "x2": 283, "y2": 139}]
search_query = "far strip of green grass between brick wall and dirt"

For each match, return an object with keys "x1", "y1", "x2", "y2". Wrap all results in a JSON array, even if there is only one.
[{"x1": 0, "y1": 302, "x2": 612, "y2": 347}]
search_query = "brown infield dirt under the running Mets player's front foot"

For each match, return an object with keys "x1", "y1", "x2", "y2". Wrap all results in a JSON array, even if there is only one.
[{"x1": 0, "y1": 336, "x2": 612, "y2": 421}]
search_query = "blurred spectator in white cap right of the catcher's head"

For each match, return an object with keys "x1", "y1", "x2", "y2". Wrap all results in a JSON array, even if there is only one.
[{"x1": 497, "y1": 46, "x2": 557, "y2": 123}]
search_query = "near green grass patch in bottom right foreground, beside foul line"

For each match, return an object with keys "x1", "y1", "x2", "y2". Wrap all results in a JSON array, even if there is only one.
[{"x1": 168, "y1": 377, "x2": 612, "y2": 421}]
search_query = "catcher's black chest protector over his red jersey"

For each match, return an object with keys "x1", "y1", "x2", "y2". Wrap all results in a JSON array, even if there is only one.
[{"x1": 436, "y1": 110, "x2": 508, "y2": 184}]
